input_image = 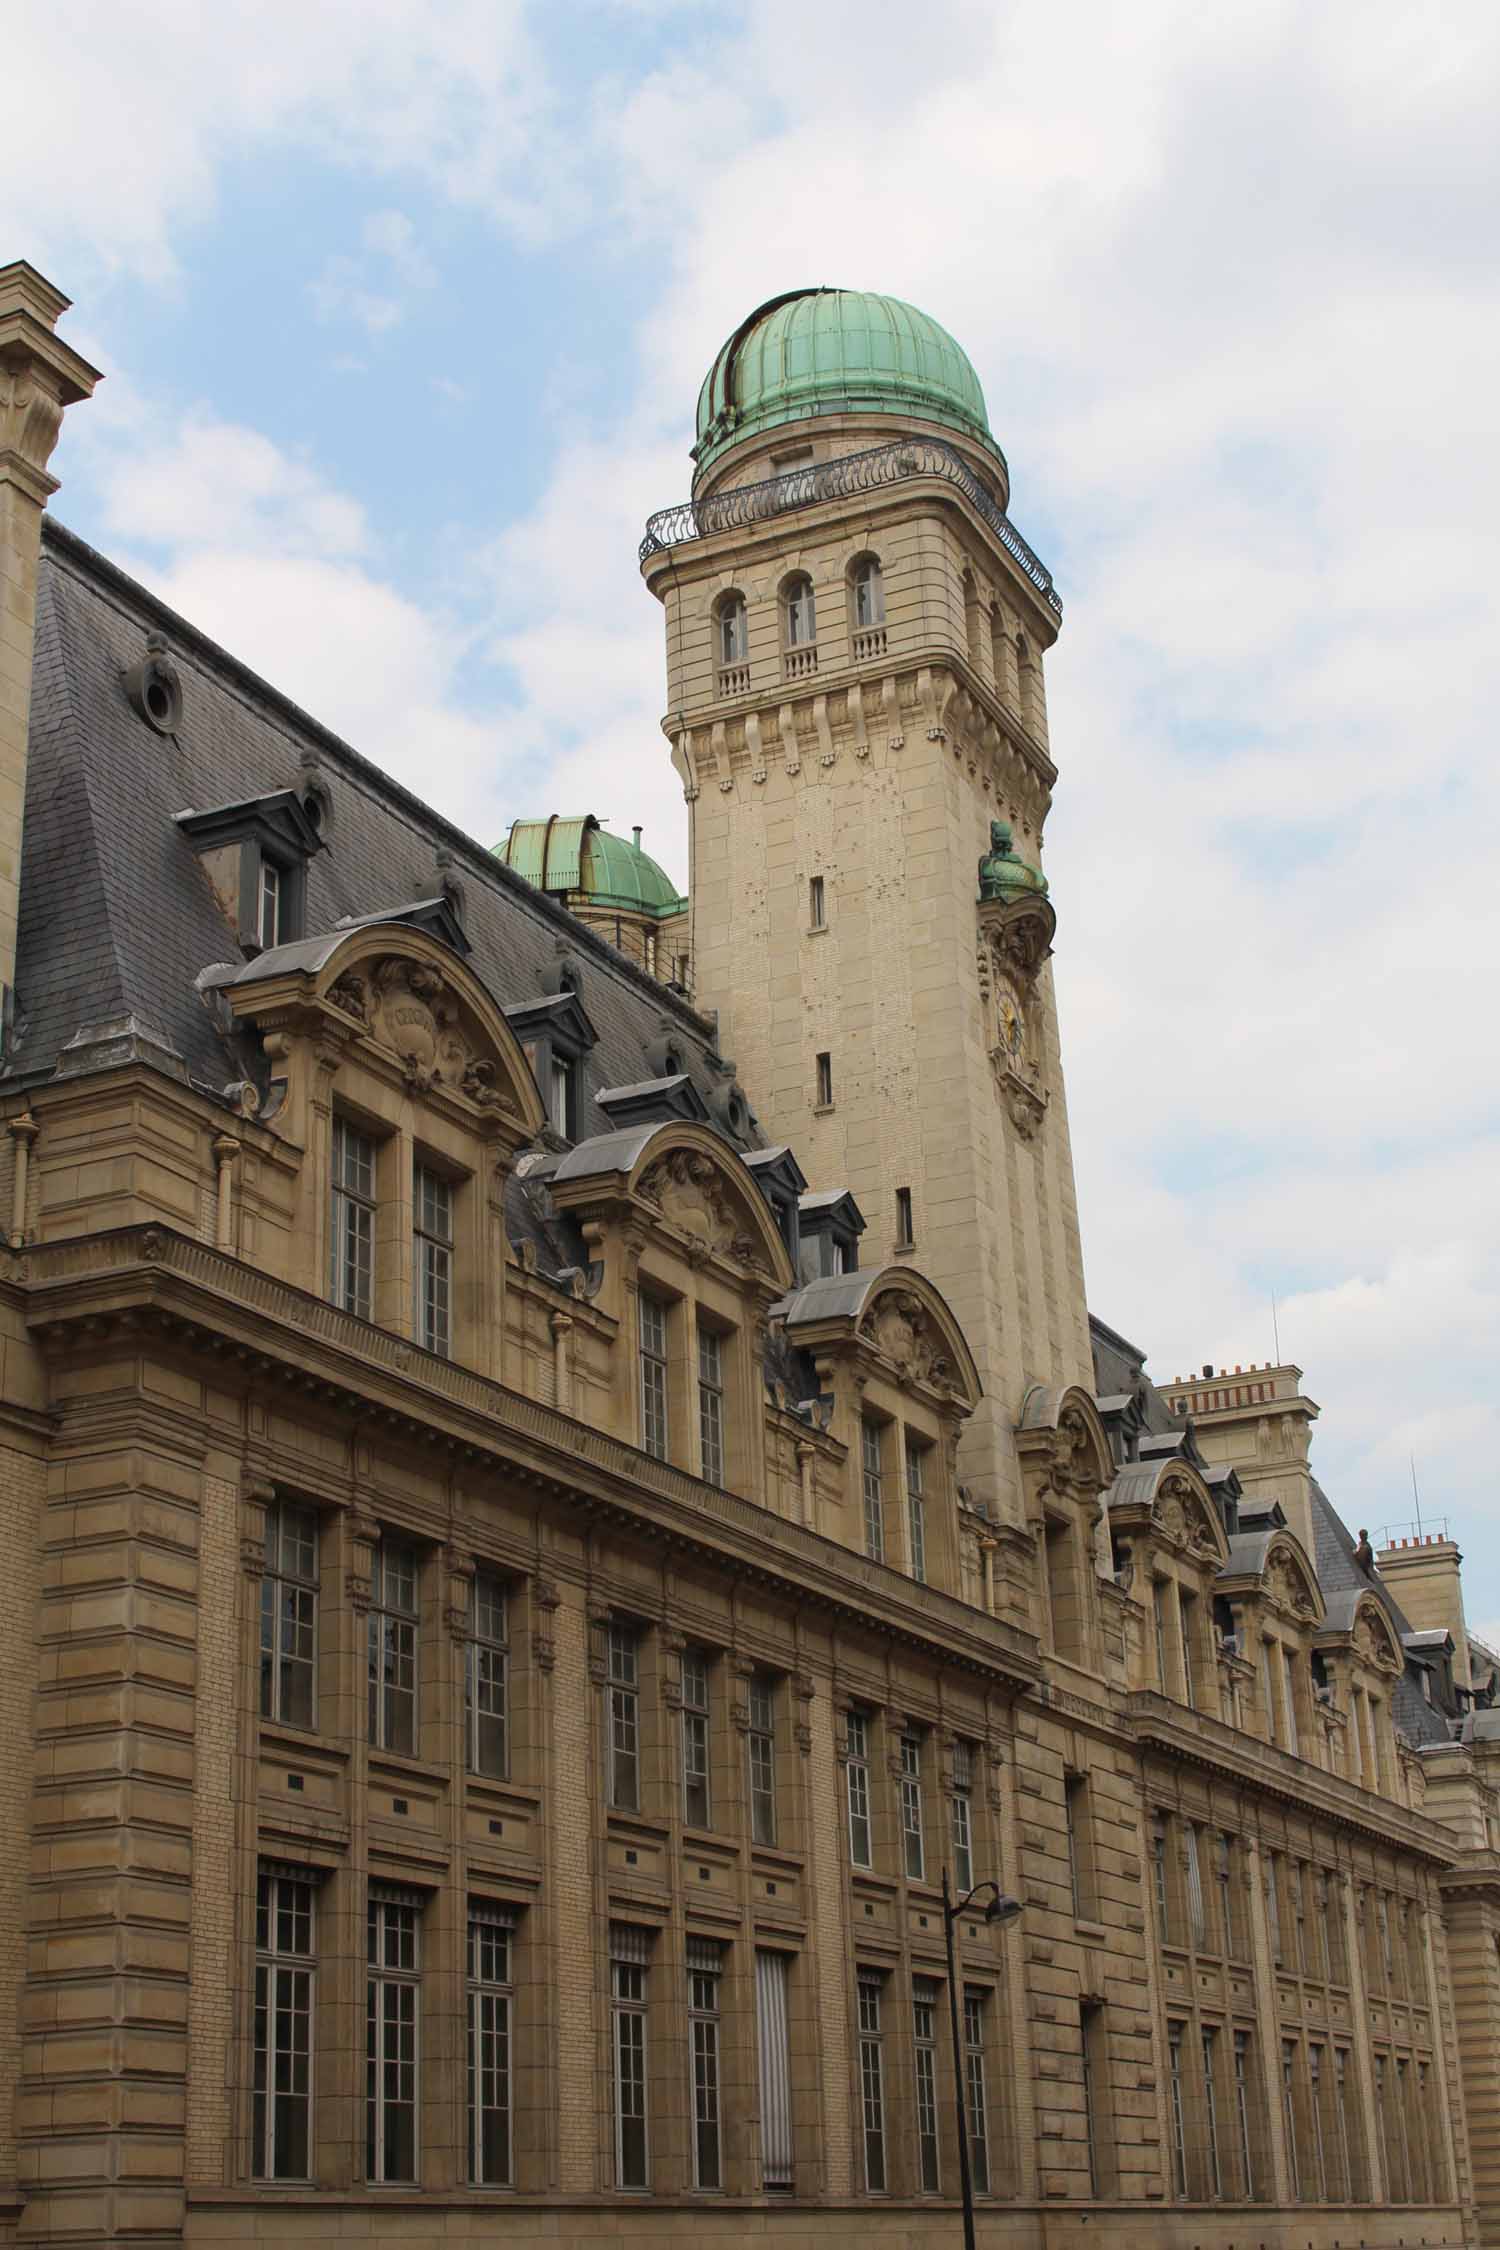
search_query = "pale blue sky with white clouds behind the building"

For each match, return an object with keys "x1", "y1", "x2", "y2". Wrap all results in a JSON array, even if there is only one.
[{"x1": 11, "y1": 0, "x2": 1500, "y2": 1636}]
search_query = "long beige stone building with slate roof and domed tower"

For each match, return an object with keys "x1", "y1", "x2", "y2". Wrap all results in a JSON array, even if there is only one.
[{"x1": 0, "y1": 268, "x2": 1500, "y2": 2250}]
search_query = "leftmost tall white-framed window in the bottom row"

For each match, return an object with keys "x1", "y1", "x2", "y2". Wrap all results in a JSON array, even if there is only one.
[{"x1": 250, "y1": 1870, "x2": 313, "y2": 2180}]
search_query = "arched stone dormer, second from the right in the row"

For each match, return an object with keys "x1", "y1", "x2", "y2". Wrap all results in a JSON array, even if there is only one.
[{"x1": 1214, "y1": 1523, "x2": 1327, "y2": 1764}]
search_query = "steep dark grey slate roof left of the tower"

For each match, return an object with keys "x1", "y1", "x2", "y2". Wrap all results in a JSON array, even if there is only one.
[{"x1": 4, "y1": 518, "x2": 737, "y2": 1170}]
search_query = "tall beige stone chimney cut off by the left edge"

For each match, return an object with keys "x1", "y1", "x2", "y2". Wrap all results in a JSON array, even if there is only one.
[{"x1": 0, "y1": 259, "x2": 99, "y2": 1030}]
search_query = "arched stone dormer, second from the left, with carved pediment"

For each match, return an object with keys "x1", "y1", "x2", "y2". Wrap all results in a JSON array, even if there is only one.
[{"x1": 549, "y1": 1118, "x2": 794, "y2": 1501}]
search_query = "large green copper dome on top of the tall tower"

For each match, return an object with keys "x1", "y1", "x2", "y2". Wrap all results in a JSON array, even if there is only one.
[{"x1": 693, "y1": 288, "x2": 1003, "y2": 470}]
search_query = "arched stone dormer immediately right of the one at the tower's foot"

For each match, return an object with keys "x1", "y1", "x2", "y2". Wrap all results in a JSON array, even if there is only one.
[{"x1": 1106, "y1": 1454, "x2": 1228, "y2": 1712}]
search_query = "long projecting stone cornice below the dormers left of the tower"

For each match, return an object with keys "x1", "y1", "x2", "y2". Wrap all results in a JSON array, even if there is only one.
[{"x1": 20, "y1": 1224, "x2": 1039, "y2": 1692}]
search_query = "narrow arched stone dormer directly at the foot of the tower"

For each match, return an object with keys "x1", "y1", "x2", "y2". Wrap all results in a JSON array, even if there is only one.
[{"x1": 1012, "y1": 1384, "x2": 1113, "y2": 1672}]
